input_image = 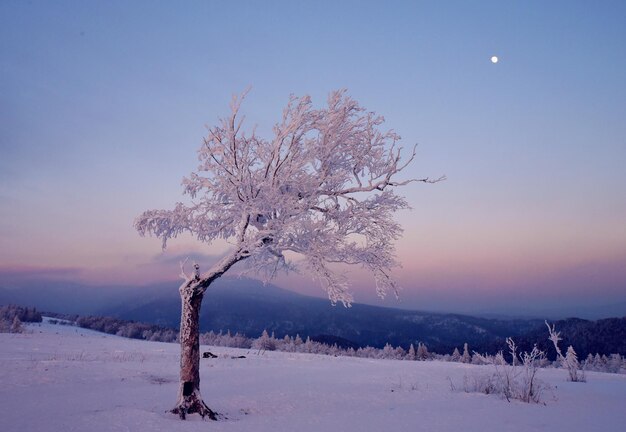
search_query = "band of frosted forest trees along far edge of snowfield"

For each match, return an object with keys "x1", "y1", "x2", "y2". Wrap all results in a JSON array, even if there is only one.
[{"x1": 0, "y1": 306, "x2": 626, "y2": 373}]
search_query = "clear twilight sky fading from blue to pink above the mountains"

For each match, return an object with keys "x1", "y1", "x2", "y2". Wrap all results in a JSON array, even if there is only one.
[{"x1": 0, "y1": 0, "x2": 626, "y2": 315}]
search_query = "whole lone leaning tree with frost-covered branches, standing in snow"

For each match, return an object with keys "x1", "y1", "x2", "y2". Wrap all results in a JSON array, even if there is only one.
[{"x1": 135, "y1": 91, "x2": 437, "y2": 419}]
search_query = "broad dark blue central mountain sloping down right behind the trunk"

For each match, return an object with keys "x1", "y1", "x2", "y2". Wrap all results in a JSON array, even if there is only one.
[{"x1": 94, "y1": 278, "x2": 542, "y2": 352}]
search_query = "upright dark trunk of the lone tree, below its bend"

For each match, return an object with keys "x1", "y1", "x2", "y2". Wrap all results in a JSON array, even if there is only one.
[{"x1": 172, "y1": 284, "x2": 217, "y2": 420}]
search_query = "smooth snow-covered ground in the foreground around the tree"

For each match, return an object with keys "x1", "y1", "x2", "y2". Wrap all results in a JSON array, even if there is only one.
[{"x1": 0, "y1": 323, "x2": 626, "y2": 432}]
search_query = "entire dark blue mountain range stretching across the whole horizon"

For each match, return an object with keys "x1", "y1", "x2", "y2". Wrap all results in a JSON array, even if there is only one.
[{"x1": 0, "y1": 278, "x2": 626, "y2": 357}]
